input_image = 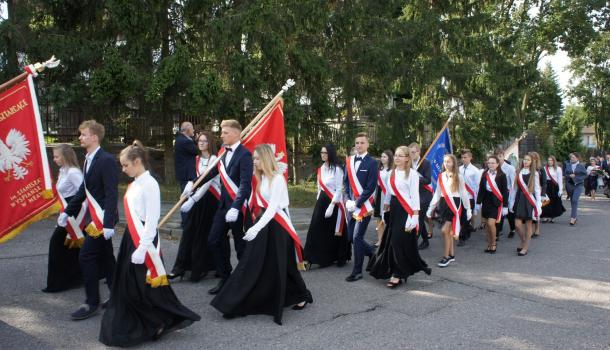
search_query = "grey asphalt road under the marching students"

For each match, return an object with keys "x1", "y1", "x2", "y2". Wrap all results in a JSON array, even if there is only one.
[{"x1": 0, "y1": 200, "x2": 610, "y2": 349}]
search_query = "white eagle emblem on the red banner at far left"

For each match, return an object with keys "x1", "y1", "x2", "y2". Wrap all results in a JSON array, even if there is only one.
[{"x1": 0, "y1": 129, "x2": 31, "y2": 181}]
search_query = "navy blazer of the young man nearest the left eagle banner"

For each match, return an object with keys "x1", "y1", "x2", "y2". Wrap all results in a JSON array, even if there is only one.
[{"x1": 66, "y1": 148, "x2": 119, "y2": 228}]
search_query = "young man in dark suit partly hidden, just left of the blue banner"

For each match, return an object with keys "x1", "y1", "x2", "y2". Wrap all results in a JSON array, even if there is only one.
[{"x1": 409, "y1": 142, "x2": 434, "y2": 250}]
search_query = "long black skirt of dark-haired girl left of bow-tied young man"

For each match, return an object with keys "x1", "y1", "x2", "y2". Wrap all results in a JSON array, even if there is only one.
[{"x1": 305, "y1": 193, "x2": 351, "y2": 266}]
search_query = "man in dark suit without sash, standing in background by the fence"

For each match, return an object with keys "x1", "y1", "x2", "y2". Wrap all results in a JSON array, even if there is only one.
[{"x1": 174, "y1": 122, "x2": 199, "y2": 227}]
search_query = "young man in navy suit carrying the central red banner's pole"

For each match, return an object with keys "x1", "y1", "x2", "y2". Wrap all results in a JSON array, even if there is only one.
[{"x1": 197, "y1": 120, "x2": 253, "y2": 294}]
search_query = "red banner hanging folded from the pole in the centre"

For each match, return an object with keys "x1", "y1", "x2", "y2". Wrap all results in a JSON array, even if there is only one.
[{"x1": 241, "y1": 99, "x2": 288, "y2": 181}]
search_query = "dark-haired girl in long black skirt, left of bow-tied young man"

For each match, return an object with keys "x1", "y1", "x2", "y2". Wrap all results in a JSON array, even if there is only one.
[{"x1": 305, "y1": 144, "x2": 351, "y2": 269}]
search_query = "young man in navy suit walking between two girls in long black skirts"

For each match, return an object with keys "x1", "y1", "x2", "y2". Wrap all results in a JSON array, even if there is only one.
[{"x1": 344, "y1": 133, "x2": 377, "y2": 282}]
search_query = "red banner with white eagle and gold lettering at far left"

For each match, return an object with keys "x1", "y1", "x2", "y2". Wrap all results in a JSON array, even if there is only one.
[{"x1": 0, "y1": 75, "x2": 61, "y2": 243}]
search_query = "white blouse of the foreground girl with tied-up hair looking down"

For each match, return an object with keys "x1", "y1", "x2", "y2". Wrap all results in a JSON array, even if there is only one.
[{"x1": 126, "y1": 170, "x2": 161, "y2": 244}]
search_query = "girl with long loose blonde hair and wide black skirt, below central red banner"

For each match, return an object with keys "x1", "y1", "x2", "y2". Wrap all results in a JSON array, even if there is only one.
[{"x1": 211, "y1": 144, "x2": 313, "y2": 324}]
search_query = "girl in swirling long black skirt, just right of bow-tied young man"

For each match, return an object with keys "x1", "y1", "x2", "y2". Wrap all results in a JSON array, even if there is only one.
[{"x1": 367, "y1": 146, "x2": 431, "y2": 288}]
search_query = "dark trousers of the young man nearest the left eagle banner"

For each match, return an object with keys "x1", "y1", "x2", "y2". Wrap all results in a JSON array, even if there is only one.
[{"x1": 78, "y1": 235, "x2": 116, "y2": 306}]
